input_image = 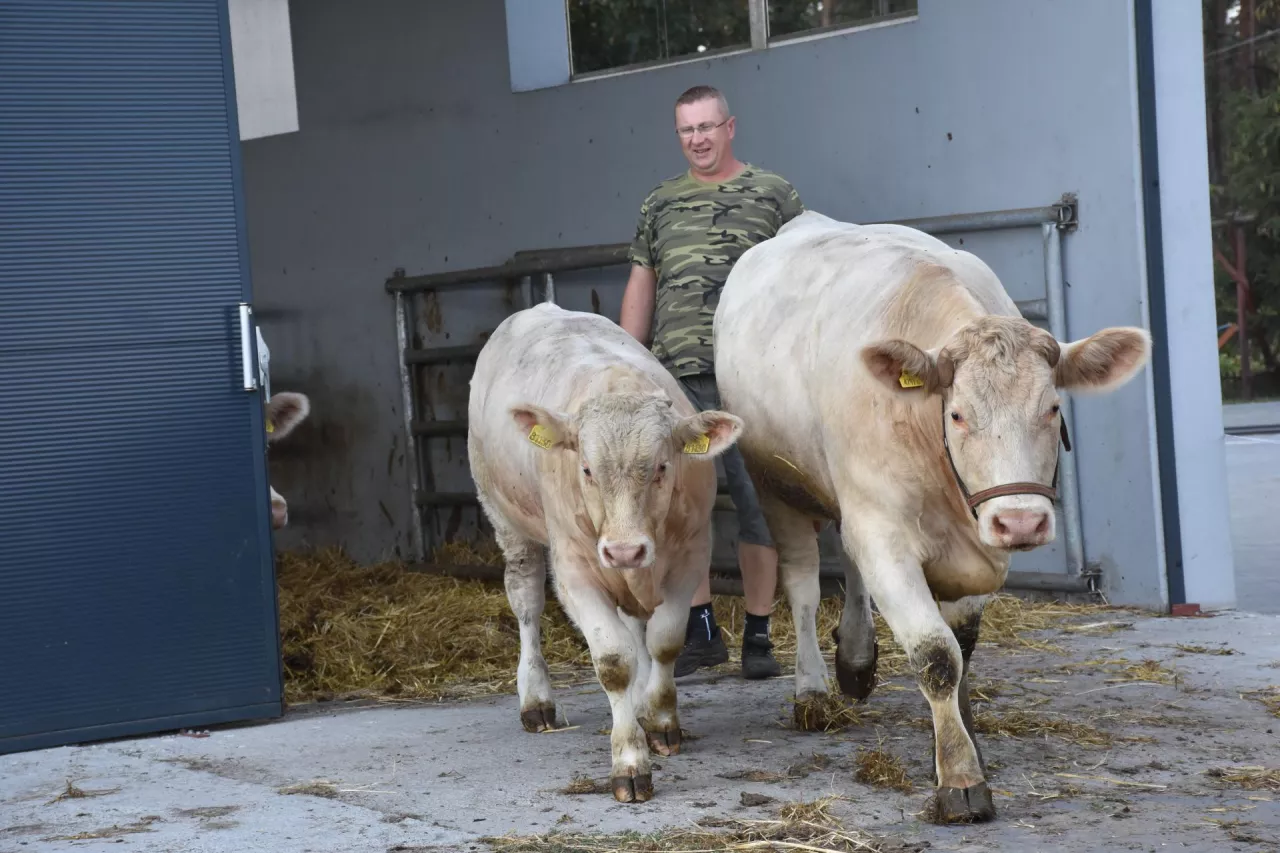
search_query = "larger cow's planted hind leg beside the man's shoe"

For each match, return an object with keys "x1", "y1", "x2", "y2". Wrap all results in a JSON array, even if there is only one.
[{"x1": 760, "y1": 492, "x2": 827, "y2": 729}]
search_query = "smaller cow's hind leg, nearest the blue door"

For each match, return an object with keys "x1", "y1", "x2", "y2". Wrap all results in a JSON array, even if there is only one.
[{"x1": 490, "y1": 516, "x2": 556, "y2": 731}]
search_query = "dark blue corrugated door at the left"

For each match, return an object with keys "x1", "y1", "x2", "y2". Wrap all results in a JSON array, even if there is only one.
[{"x1": 0, "y1": 0, "x2": 280, "y2": 752}]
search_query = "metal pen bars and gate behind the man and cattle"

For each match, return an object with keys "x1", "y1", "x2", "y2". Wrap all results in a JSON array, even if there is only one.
[{"x1": 385, "y1": 193, "x2": 1097, "y2": 594}]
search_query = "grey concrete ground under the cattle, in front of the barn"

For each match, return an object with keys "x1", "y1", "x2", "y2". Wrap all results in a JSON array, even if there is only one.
[{"x1": 0, "y1": 604, "x2": 1280, "y2": 853}]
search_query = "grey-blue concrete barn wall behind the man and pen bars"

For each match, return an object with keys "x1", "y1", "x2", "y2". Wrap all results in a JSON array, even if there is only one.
[{"x1": 244, "y1": 0, "x2": 1187, "y2": 606}]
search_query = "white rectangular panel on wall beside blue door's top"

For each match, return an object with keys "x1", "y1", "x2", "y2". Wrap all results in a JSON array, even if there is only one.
[{"x1": 228, "y1": 0, "x2": 298, "y2": 140}]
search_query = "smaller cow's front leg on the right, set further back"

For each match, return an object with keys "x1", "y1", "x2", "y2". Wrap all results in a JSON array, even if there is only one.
[{"x1": 636, "y1": 529, "x2": 712, "y2": 756}]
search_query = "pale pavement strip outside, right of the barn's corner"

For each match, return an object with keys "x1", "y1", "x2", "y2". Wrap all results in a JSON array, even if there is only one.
[{"x1": 1226, "y1": 432, "x2": 1280, "y2": 613}]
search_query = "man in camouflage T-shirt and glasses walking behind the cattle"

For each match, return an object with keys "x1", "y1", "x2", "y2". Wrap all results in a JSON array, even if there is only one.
[{"x1": 618, "y1": 86, "x2": 804, "y2": 679}]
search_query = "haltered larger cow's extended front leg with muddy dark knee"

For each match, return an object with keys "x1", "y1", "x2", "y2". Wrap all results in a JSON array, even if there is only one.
[{"x1": 844, "y1": 515, "x2": 996, "y2": 824}]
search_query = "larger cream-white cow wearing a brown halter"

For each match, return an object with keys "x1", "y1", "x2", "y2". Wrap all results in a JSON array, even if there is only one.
[{"x1": 714, "y1": 211, "x2": 1149, "y2": 821}]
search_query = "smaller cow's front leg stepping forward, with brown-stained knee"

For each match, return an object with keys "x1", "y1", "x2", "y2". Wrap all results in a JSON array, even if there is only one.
[{"x1": 557, "y1": 573, "x2": 653, "y2": 803}]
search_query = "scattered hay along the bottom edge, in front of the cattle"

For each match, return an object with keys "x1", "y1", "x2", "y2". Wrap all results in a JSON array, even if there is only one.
[{"x1": 480, "y1": 798, "x2": 920, "y2": 853}]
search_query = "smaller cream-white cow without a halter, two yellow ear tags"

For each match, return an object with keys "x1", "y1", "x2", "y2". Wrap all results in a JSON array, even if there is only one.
[{"x1": 467, "y1": 304, "x2": 742, "y2": 803}]
